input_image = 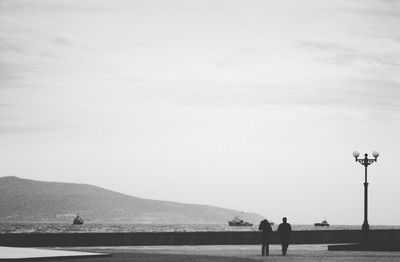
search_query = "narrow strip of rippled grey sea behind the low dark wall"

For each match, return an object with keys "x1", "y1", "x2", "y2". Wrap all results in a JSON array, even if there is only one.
[{"x1": 0, "y1": 223, "x2": 400, "y2": 233}]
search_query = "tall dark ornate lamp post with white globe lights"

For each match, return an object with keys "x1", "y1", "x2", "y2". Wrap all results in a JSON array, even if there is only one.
[{"x1": 353, "y1": 151, "x2": 379, "y2": 242}]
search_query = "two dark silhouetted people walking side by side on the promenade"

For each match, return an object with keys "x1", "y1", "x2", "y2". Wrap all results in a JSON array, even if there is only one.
[{"x1": 258, "y1": 217, "x2": 292, "y2": 256}]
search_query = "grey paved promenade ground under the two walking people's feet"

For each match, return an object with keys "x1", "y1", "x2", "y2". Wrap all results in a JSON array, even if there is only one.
[{"x1": 41, "y1": 245, "x2": 400, "y2": 262}]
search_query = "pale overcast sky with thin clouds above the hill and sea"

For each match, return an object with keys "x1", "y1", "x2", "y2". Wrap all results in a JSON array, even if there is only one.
[{"x1": 0, "y1": 0, "x2": 400, "y2": 225}]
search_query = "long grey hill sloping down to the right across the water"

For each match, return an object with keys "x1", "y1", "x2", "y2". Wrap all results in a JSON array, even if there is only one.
[{"x1": 0, "y1": 176, "x2": 262, "y2": 224}]
